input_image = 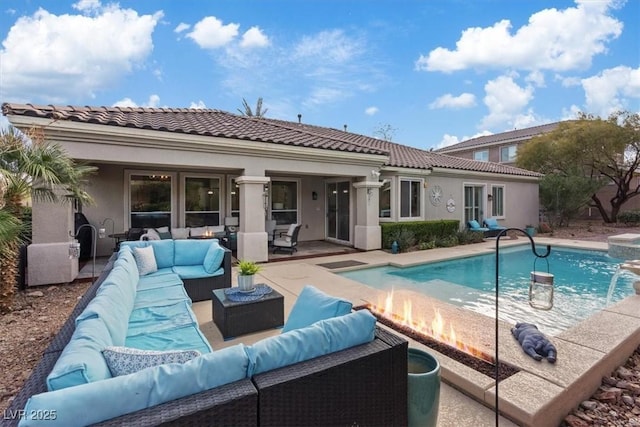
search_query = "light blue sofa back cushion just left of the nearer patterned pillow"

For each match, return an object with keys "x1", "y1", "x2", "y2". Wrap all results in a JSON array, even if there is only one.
[{"x1": 47, "y1": 318, "x2": 113, "y2": 391}]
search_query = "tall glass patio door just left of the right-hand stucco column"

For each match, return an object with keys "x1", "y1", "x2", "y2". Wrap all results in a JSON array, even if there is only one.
[{"x1": 326, "y1": 181, "x2": 351, "y2": 242}]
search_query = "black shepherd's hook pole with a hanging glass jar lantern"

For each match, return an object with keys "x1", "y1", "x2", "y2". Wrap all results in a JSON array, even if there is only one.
[{"x1": 494, "y1": 228, "x2": 553, "y2": 427}]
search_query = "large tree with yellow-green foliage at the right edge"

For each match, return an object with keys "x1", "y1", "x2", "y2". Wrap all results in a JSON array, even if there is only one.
[{"x1": 517, "y1": 112, "x2": 640, "y2": 223}]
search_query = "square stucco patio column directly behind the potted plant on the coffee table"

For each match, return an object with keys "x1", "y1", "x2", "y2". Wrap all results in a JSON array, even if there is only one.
[{"x1": 236, "y1": 176, "x2": 270, "y2": 262}]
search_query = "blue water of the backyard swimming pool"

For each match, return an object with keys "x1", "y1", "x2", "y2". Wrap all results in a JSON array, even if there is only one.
[{"x1": 336, "y1": 245, "x2": 638, "y2": 335}]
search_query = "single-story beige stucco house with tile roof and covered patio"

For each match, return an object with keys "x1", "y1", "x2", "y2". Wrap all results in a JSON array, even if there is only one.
[{"x1": 2, "y1": 103, "x2": 541, "y2": 284}]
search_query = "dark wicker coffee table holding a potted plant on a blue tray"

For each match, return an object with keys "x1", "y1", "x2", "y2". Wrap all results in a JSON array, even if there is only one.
[{"x1": 211, "y1": 284, "x2": 284, "y2": 339}]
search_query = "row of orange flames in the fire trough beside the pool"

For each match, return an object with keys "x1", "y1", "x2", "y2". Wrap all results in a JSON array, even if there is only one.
[{"x1": 369, "y1": 291, "x2": 493, "y2": 363}]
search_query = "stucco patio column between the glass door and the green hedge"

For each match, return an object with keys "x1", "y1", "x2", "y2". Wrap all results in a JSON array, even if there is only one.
[{"x1": 353, "y1": 181, "x2": 382, "y2": 251}]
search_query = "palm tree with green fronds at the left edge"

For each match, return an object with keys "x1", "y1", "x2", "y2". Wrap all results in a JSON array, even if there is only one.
[{"x1": 0, "y1": 127, "x2": 96, "y2": 312}]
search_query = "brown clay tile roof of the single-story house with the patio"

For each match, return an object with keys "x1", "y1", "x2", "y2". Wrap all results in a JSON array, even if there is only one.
[{"x1": 2, "y1": 103, "x2": 542, "y2": 177}]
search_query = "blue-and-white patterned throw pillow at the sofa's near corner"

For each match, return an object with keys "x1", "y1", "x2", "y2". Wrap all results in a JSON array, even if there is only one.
[{"x1": 102, "y1": 346, "x2": 200, "y2": 377}]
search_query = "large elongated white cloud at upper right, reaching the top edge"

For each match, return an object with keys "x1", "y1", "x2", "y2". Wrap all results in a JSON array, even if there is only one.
[{"x1": 415, "y1": 0, "x2": 623, "y2": 73}]
